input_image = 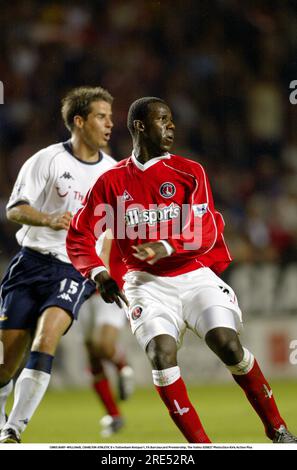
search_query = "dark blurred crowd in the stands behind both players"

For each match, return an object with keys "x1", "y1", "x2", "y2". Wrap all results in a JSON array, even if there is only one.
[{"x1": 0, "y1": 0, "x2": 297, "y2": 262}]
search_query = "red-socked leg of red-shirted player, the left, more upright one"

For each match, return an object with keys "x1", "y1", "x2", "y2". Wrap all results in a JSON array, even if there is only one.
[{"x1": 146, "y1": 335, "x2": 210, "y2": 443}]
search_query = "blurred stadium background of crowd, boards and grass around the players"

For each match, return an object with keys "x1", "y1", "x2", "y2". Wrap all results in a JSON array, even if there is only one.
[{"x1": 0, "y1": 0, "x2": 297, "y2": 442}]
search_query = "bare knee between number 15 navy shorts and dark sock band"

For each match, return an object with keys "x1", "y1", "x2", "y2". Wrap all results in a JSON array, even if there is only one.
[{"x1": 32, "y1": 306, "x2": 73, "y2": 355}]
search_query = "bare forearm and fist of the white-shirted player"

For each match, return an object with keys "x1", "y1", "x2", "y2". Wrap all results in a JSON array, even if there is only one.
[{"x1": 6, "y1": 204, "x2": 72, "y2": 231}]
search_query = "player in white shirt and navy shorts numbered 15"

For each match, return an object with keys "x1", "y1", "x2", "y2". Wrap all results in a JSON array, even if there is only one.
[{"x1": 0, "y1": 87, "x2": 132, "y2": 443}]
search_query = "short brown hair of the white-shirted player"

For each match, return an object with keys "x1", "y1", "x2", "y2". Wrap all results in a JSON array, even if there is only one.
[{"x1": 61, "y1": 86, "x2": 113, "y2": 131}]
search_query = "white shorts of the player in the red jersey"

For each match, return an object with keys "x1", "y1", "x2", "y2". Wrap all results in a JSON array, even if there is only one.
[{"x1": 124, "y1": 268, "x2": 242, "y2": 350}]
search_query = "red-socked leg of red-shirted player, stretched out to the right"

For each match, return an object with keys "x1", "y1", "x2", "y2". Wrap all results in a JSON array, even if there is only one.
[{"x1": 205, "y1": 327, "x2": 297, "y2": 442}]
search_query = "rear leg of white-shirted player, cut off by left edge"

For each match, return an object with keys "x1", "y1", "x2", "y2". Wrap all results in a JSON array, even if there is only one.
[{"x1": 0, "y1": 330, "x2": 31, "y2": 430}]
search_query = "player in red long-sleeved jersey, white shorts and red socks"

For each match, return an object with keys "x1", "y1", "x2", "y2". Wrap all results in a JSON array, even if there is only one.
[{"x1": 67, "y1": 97, "x2": 297, "y2": 443}]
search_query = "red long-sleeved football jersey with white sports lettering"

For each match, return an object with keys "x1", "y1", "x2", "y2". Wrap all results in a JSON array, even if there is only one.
[{"x1": 67, "y1": 154, "x2": 232, "y2": 277}]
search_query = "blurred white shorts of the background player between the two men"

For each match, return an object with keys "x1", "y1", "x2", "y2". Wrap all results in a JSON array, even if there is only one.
[{"x1": 77, "y1": 294, "x2": 127, "y2": 341}]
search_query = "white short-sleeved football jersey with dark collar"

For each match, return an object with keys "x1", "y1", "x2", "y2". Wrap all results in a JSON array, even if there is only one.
[{"x1": 7, "y1": 141, "x2": 116, "y2": 263}]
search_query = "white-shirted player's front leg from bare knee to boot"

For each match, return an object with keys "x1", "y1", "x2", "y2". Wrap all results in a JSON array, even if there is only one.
[{"x1": 0, "y1": 307, "x2": 72, "y2": 443}]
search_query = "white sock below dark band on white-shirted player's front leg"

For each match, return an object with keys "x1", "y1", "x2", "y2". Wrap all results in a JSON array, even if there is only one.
[{"x1": 4, "y1": 368, "x2": 51, "y2": 434}]
